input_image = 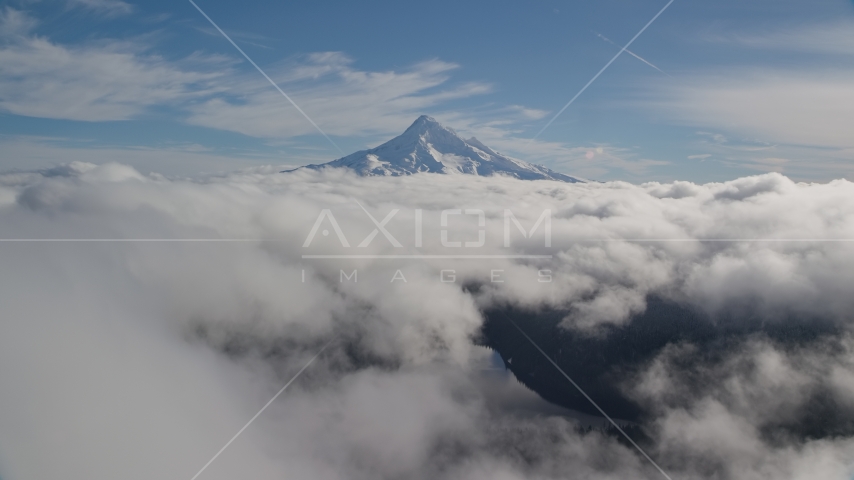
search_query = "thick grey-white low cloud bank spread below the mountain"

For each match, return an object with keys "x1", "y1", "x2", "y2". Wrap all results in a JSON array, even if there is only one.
[{"x1": 0, "y1": 163, "x2": 854, "y2": 479}]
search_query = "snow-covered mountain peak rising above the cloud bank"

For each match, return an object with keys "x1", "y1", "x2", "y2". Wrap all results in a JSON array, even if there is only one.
[{"x1": 290, "y1": 115, "x2": 582, "y2": 183}]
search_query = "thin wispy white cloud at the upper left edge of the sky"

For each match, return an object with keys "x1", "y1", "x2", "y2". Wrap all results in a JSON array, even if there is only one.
[{"x1": 0, "y1": 9, "x2": 228, "y2": 121}]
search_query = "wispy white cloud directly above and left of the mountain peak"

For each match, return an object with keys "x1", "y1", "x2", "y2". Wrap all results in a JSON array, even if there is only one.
[{"x1": 187, "y1": 52, "x2": 492, "y2": 138}]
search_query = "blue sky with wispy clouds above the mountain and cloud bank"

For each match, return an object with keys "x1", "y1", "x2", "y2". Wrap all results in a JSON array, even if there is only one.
[{"x1": 0, "y1": 0, "x2": 854, "y2": 182}]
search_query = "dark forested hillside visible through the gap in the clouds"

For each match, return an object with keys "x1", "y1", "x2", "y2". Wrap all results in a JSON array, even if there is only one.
[{"x1": 480, "y1": 298, "x2": 854, "y2": 436}]
